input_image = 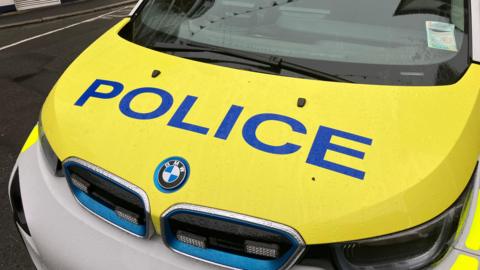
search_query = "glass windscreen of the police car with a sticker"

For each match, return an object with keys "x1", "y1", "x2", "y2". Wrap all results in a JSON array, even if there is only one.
[{"x1": 124, "y1": 0, "x2": 469, "y2": 85}]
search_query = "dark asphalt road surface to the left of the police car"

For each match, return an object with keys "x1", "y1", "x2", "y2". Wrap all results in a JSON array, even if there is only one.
[{"x1": 0, "y1": 7, "x2": 131, "y2": 270}]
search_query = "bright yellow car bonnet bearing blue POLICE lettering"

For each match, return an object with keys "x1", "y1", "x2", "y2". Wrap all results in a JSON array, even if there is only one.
[{"x1": 41, "y1": 19, "x2": 480, "y2": 244}]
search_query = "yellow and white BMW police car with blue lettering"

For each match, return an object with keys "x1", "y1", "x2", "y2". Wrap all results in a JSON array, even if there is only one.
[{"x1": 9, "y1": 0, "x2": 480, "y2": 270}]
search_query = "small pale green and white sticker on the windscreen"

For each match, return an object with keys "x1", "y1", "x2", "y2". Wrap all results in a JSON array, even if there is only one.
[{"x1": 425, "y1": 21, "x2": 458, "y2": 52}]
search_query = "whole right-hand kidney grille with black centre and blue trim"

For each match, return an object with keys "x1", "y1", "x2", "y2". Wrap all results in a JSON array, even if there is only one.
[{"x1": 161, "y1": 204, "x2": 305, "y2": 270}]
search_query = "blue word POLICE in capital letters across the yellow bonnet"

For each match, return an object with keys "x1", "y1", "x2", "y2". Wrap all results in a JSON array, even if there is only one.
[{"x1": 74, "y1": 79, "x2": 373, "y2": 180}]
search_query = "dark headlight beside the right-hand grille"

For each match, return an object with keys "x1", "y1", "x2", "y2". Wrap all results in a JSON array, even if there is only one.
[{"x1": 334, "y1": 179, "x2": 472, "y2": 270}]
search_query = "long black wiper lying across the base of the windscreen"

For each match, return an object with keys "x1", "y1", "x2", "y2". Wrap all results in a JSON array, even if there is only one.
[{"x1": 150, "y1": 42, "x2": 352, "y2": 83}]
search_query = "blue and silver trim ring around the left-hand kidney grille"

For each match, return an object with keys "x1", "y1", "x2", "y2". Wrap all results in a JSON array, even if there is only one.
[{"x1": 64, "y1": 161, "x2": 148, "y2": 238}]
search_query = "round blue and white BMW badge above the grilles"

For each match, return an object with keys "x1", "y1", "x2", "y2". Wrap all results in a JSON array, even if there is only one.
[{"x1": 154, "y1": 157, "x2": 190, "y2": 193}]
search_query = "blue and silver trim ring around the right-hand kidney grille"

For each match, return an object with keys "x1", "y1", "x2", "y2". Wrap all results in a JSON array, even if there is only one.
[{"x1": 161, "y1": 208, "x2": 304, "y2": 270}]
